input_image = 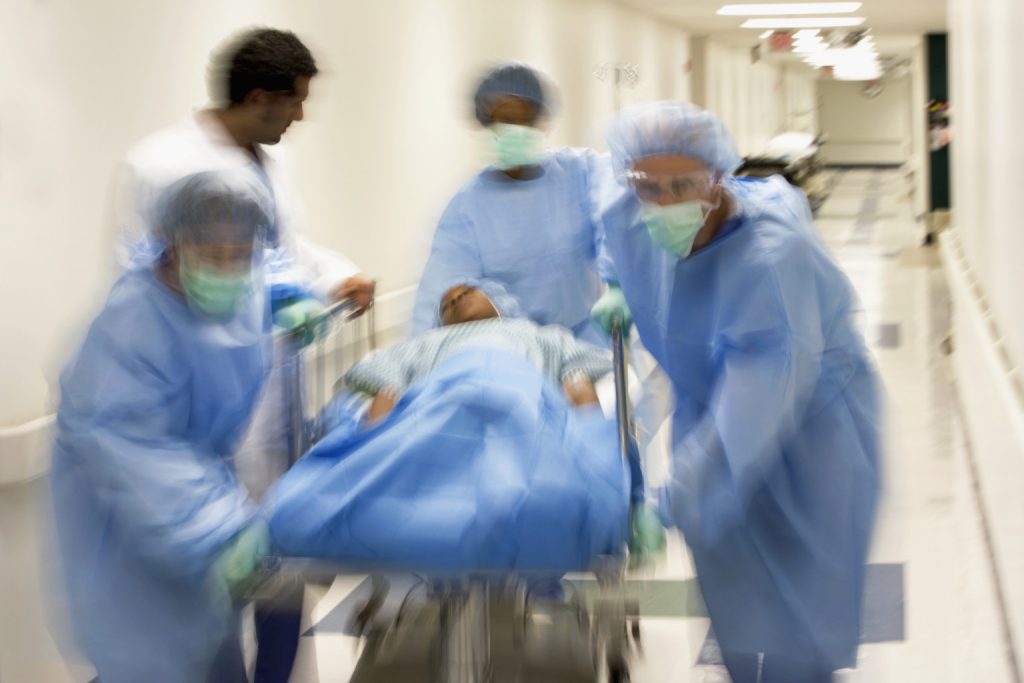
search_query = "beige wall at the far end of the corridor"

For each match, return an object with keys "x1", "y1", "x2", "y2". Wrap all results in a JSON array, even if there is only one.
[{"x1": 818, "y1": 78, "x2": 916, "y2": 164}]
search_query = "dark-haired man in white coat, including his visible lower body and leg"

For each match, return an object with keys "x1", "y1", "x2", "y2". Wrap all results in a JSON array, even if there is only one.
[{"x1": 119, "y1": 29, "x2": 374, "y2": 683}]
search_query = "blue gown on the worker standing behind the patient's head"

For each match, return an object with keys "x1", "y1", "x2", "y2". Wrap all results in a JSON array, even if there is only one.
[{"x1": 412, "y1": 148, "x2": 611, "y2": 343}]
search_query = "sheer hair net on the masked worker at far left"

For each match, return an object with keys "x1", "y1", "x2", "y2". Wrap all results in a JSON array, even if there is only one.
[{"x1": 157, "y1": 170, "x2": 274, "y2": 244}]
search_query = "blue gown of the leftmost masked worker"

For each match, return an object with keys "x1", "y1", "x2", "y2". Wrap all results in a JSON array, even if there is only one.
[{"x1": 52, "y1": 270, "x2": 269, "y2": 683}]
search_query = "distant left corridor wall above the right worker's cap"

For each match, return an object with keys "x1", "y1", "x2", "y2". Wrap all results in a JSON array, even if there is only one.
[{"x1": 692, "y1": 38, "x2": 818, "y2": 156}]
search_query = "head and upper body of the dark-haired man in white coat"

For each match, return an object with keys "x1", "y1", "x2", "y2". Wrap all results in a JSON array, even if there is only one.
[{"x1": 118, "y1": 29, "x2": 374, "y2": 317}]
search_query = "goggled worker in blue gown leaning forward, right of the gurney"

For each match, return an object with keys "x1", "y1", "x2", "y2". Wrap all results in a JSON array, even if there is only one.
[{"x1": 602, "y1": 102, "x2": 881, "y2": 683}]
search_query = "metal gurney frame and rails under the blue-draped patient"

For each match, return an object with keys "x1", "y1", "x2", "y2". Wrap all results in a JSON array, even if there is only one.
[{"x1": 248, "y1": 306, "x2": 642, "y2": 683}]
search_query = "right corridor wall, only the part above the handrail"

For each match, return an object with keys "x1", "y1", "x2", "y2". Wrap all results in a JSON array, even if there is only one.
[{"x1": 950, "y1": 0, "x2": 1024, "y2": 364}]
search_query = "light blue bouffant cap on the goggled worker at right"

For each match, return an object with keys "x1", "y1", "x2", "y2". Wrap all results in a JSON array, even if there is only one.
[{"x1": 606, "y1": 100, "x2": 742, "y2": 176}]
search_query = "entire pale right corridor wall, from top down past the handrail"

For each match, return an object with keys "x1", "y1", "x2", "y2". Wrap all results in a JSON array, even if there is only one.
[{"x1": 943, "y1": 0, "x2": 1024, "y2": 650}]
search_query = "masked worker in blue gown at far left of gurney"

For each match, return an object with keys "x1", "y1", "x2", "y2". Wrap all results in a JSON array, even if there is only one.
[{"x1": 52, "y1": 171, "x2": 273, "y2": 683}]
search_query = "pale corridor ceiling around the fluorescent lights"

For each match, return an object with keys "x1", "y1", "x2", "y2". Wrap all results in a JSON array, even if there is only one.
[{"x1": 620, "y1": 0, "x2": 946, "y2": 51}]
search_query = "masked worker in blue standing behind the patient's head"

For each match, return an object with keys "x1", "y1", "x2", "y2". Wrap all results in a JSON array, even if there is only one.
[{"x1": 412, "y1": 62, "x2": 611, "y2": 343}]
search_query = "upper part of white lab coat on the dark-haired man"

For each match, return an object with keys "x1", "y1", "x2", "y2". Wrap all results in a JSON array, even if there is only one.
[{"x1": 115, "y1": 112, "x2": 359, "y2": 299}]
